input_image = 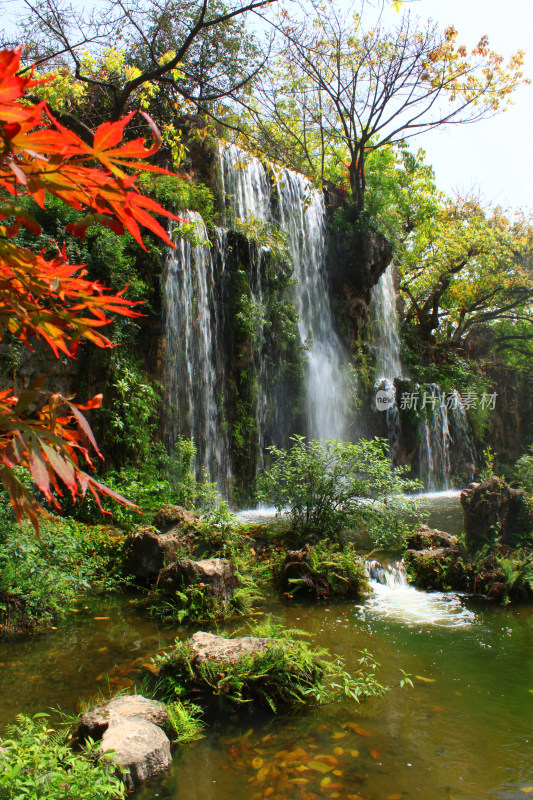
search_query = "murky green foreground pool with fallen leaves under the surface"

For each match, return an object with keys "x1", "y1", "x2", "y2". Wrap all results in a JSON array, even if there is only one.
[{"x1": 0, "y1": 495, "x2": 533, "y2": 800}]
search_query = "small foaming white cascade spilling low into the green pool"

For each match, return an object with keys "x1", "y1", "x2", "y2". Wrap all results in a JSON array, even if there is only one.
[{"x1": 360, "y1": 561, "x2": 476, "y2": 628}]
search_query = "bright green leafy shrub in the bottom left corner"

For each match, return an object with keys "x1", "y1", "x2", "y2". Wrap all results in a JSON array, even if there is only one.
[{"x1": 0, "y1": 714, "x2": 125, "y2": 800}]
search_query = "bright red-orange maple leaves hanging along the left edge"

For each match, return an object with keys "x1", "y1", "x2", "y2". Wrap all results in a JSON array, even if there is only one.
[{"x1": 0, "y1": 49, "x2": 179, "y2": 529}]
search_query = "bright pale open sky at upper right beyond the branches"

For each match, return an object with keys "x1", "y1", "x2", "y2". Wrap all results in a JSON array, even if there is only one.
[{"x1": 393, "y1": 0, "x2": 533, "y2": 209}]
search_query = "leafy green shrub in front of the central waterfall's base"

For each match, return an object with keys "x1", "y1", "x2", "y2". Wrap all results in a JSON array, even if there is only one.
[{"x1": 259, "y1": 436, "x2": 419, "y2": 542}]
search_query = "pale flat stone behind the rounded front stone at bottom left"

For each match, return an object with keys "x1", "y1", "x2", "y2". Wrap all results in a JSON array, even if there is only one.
[{"x1": 78, "y1": 694, "x2": 168, "y2": 739}]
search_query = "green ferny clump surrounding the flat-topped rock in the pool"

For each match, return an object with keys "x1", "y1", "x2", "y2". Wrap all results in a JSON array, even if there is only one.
[{"x1": 150, "y1": 620, "x2": 384, "y2": 712}]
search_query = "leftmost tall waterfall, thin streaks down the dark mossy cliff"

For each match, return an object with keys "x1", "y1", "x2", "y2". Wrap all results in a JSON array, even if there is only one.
[{"x1": 164, "y1": 211, "x2": 229, "y2": 489}]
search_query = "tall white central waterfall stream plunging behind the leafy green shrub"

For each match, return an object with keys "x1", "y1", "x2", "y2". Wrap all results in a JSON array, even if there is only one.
[{"x1": 277, "y1": 169, "x2": 348, "y2": 440}]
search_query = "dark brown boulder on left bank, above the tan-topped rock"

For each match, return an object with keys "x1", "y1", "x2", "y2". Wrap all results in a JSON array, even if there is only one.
[{"x1": 123, "y1": 528, "x2": 183, "y2": 582}]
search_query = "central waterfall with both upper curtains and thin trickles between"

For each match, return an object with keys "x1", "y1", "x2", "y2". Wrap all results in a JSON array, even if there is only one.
[{"x1": 219, "y1": 145, "x2": 347, "y2": 446}]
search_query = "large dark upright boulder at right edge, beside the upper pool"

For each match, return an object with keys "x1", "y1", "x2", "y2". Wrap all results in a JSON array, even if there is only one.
[{"x1": 461, "y1": 476, "x2": 533, "y2": 550}]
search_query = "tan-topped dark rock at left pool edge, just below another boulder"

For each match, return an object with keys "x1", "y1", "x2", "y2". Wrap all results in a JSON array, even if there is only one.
[{"x1": 157, "y1": 558, "x2": 237, "y2": 600}]
